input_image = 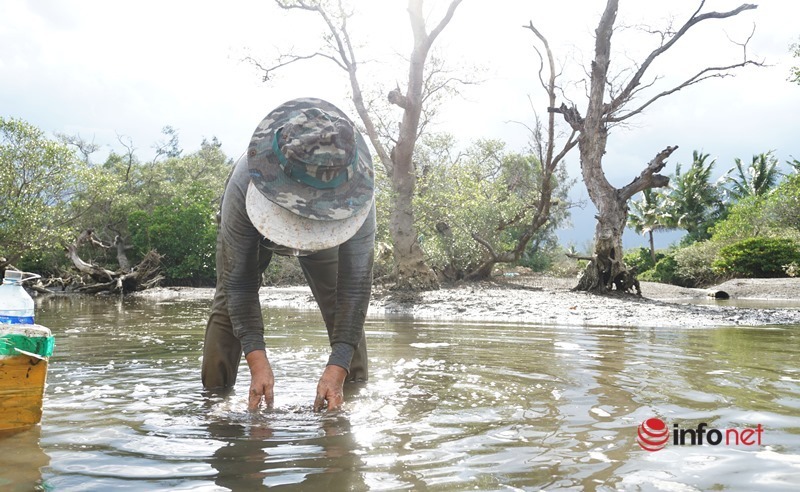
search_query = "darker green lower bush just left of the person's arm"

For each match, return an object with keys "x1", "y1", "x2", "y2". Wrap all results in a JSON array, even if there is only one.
[{"x1": 128, "y1": 186, "x2": 217, "y2": 283}]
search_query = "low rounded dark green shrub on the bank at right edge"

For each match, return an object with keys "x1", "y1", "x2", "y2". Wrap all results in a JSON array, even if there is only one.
[{"x1": 712, "y1": 237, "x2": 800, "y2": 277}]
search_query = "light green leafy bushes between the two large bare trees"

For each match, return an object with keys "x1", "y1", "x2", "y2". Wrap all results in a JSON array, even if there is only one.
[{"x1": 414, "y1": 136, "x2": 570, "y2": 279}]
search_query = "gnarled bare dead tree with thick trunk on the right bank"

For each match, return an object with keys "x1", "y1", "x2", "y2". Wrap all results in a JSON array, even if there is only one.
[{"x1": 525, "y1": 0, "x2": 762, "y2": 292}]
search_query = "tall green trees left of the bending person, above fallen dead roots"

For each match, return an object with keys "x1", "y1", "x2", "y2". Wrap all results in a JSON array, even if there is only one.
[{"x1": 69, "y1": 136, "x2": 231, "y2": 284}]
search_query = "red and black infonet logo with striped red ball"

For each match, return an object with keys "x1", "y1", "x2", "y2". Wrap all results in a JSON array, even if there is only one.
[{"x1": 636, "y1": 418, "x2": 764, "y2": 452}]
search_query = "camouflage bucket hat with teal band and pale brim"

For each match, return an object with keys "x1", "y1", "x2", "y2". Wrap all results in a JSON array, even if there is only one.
[{"x1": 246, "y1": 98, "x2": 375, "y2": 250}]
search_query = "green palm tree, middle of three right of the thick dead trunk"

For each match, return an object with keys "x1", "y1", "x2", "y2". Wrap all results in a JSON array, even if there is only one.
[{"x1": 667, "y1": 150, "x2": 722, "y2": 240}]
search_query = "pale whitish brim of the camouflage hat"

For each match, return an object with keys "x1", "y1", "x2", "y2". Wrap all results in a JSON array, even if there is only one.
[{"x1": 246, "y1": 182, "x2": 372, "y2": 251}]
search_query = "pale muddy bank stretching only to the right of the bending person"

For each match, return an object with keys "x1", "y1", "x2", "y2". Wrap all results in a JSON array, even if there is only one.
[{"x1": 378, "y1": 278, "x2": 800, "y2": 327}]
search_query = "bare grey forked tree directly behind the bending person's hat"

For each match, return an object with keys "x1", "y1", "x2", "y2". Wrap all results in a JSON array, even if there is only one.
[{"x1": 249, "y1": 0, "x2": 461, "y2": 290}]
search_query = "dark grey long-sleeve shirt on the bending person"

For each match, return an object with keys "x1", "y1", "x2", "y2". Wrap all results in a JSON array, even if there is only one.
[{"x1": 217, "y1": 156, "x2": 375, "y2": 370}]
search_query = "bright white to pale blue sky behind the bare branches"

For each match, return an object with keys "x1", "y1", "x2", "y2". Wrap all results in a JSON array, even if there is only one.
[{"x1": 0, "y1": 0, "x2": 800, "y2": 252}]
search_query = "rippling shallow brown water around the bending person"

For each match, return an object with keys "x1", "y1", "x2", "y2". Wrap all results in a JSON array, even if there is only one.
[{"x1": 0, "y1": 298, "x2": 800, "y2": 491}]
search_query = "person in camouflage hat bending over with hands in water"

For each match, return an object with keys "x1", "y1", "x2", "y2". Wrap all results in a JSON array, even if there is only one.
[{"x1": 202, "y1": 98, "x2": 375, "y2": 411}]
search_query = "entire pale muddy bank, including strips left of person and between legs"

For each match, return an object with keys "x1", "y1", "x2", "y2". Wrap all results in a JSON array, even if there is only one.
[{"x1": 138, "y1": 276, "x2": 800, "y2": 327}]
